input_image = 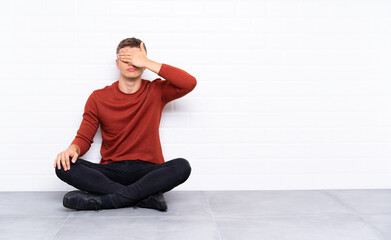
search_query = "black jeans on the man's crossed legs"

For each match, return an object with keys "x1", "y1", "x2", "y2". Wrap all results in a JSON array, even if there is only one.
[{"x1": 55, "y1": 157, "x2": 191, "y2": 208}]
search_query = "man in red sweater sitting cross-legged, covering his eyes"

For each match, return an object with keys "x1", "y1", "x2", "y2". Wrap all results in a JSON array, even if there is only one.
[{"x1": 54, "y1": 38, "x2": 197, "y2": 211}]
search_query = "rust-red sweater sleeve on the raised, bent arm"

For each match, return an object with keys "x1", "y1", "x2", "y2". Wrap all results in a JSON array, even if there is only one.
[{"x1": 158, "y1": 63, "x2": 197, "y2": 103}]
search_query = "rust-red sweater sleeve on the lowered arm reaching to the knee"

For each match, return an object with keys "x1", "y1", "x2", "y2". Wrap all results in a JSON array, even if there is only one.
[{"x1": 71, "y1": 91, "x2": 99, "y2": 157}]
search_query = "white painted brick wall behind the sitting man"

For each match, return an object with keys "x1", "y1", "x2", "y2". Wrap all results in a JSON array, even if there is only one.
[{"x1": 0, "y1": 0, "x2": 391, "y2": 191}]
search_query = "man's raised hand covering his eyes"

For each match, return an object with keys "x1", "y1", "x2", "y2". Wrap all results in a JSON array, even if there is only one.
[{"x1": 118, "y1": 42, "x2": 149, "y2": 68}]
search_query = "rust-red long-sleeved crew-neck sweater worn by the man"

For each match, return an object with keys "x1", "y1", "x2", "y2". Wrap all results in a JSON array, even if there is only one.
[{"x1": 71, "y1": 63, "x2": 197, "y2": 164}]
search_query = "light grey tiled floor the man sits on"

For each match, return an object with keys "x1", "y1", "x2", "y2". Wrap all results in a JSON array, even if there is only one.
[{"x1": 0, "y1": 190, "x2": 391, "y2": 240}]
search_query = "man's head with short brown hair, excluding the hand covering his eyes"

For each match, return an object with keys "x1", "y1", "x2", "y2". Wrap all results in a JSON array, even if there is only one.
[{"x1": 115, "y1": 37, "x2": 147, "y2": 79}]
